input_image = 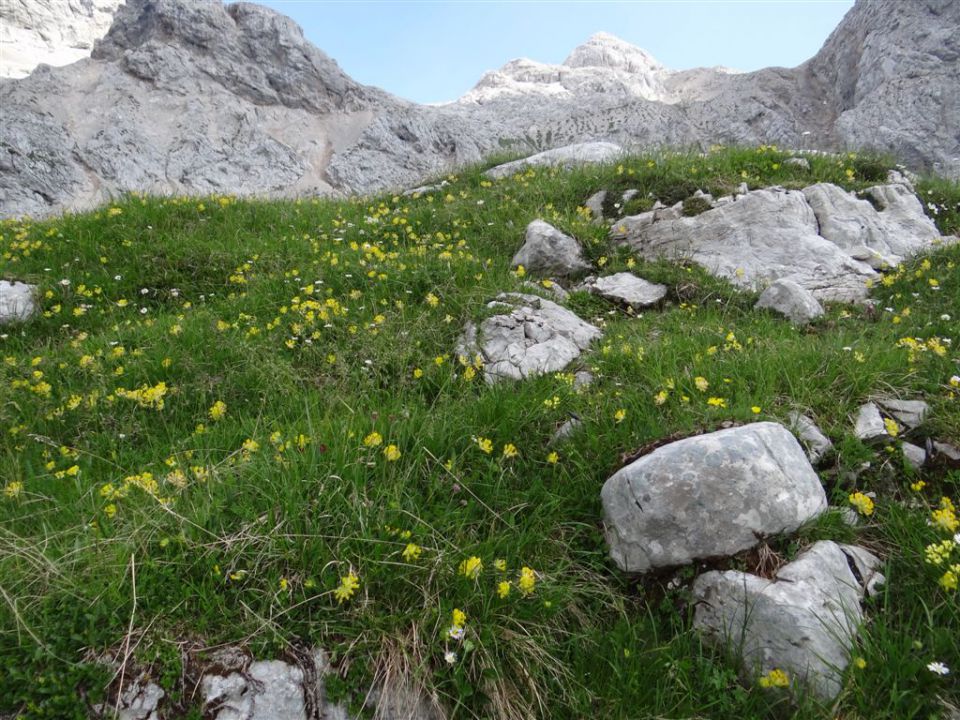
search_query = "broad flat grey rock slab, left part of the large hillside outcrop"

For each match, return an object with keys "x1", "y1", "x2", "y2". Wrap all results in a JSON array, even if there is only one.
[{"x1": 612, "y1": 188, "x2": 876, "y2": 301}]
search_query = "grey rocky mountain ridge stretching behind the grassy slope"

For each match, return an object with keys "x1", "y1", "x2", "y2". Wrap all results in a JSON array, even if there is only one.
[{"x1": 0, "y1": 0, "x2": 960, "y2": 215}]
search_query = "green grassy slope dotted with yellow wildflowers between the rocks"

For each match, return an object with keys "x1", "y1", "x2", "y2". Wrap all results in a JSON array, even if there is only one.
[{"x1": 0, "y1": 143, "x2": 960, "y2": 718}]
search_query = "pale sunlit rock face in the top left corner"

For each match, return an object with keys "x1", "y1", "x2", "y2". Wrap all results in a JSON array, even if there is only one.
[{"x1": 0, "y1": 0, "x2": 123, "y2": 78}]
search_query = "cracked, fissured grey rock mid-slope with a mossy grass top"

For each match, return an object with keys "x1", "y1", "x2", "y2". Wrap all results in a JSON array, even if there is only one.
[{"x1": 456, "y1": 293, "x2": 603, "y2": 384}]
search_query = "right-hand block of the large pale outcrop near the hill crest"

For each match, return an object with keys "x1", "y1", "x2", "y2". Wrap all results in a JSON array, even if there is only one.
[{"x1": 803, "y1": 183, "x2": 940, "y2": 269}]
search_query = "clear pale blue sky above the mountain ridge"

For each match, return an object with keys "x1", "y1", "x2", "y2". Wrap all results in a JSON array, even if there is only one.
[{"x1": 259, "y1": 0, "x2": 856, "y2": 103}]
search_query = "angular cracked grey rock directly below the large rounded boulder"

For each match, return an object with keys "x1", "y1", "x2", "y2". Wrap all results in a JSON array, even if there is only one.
[{"x1": 693, "y1": 540, "x2": 883, "y2": 700}]
